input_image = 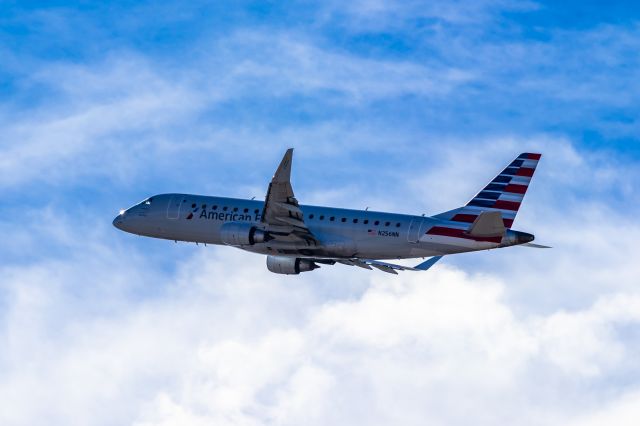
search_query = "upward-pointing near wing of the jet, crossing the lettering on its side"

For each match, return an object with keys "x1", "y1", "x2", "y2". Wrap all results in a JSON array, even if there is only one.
[{"x1": 261, "y1": 148, "x2": 317, "y2": 246}]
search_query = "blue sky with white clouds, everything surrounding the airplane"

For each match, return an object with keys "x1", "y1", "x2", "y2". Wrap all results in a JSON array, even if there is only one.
[{"x1": 0, "y1": 0, "x2": 640, "y2": 424}]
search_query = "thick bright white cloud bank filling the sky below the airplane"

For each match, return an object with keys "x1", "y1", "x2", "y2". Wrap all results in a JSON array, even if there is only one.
[{"x1": 0, "y1": 233, "x2": 640, "y2": 425}]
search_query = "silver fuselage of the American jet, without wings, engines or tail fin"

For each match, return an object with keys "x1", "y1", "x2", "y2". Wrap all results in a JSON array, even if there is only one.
[{"x1": 113, "y1": 194, "x2": 533, "y2": 259}]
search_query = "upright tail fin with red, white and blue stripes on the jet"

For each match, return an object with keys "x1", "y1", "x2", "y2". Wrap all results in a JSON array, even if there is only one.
[{"x1": 434, "y1": 153, "x2": 542, "y2": 228}]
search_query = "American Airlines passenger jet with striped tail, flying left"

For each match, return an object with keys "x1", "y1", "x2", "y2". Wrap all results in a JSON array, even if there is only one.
[{"x1": 113, "y1": 148, "x2": 547, "y2": 275}]
